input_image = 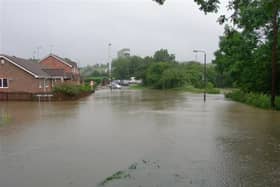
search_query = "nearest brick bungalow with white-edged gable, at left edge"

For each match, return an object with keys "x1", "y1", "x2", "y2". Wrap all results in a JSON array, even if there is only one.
[{"x1": 0, "y1": 54, "x2": 64, "y2": 93}]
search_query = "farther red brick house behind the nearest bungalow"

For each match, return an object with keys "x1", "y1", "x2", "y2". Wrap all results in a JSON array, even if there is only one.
[{"x1": 39, "y1": 54, "x2": 81, "y2": 84}]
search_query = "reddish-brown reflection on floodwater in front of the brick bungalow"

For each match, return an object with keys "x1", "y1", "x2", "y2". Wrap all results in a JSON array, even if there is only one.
[{"x1": 0, "y1": 102, "x2": 80, "y2": 134}]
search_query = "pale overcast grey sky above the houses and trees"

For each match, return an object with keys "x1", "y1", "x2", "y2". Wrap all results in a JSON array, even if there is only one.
[{"x1": 0, "y1": 0, "x2": 228, "y2": 65}]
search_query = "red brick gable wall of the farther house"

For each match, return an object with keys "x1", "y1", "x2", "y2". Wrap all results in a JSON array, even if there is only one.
[{"x1": 40, "y1": 56, "x2": 72, "y2": 73}]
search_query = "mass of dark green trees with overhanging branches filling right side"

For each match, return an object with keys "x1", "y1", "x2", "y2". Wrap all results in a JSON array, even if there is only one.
[{"x1": 155, "y1": 0, "x2": 280, "y2": 107}]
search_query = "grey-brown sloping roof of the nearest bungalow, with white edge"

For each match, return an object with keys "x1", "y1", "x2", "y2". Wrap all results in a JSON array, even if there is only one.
[{"x1": 0, "y1": 54, "x2": 50, "y2": 78}]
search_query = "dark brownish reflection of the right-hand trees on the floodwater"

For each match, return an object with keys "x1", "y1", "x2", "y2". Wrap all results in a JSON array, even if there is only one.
[{"x1": 215, "y1": 103, "x2": 280, "y2": 186}]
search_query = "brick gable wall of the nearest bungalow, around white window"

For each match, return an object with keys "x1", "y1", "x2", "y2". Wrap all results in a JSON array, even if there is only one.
[{"x1": 0, "y1": 60, "x2": 51, "y2": 93}]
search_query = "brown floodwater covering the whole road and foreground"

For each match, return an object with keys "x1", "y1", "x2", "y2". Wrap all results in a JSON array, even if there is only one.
[{"x1": 0, "y1": 90, "x2": 280, "y2": 187}]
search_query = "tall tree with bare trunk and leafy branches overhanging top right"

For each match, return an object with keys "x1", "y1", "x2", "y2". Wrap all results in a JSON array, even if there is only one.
[{"x1": 154, "y1": 0, "x2": 280, "y2": 107}]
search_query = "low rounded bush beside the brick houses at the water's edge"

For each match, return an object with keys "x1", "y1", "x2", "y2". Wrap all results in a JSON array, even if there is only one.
[{"x1": 52, "y1": 84, "x2": 91, "y2": 97}]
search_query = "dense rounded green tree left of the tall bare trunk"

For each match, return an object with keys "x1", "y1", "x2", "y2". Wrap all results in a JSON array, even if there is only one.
[{"x1": 214, "y1": 30, "x2": 271, "y2": 93}]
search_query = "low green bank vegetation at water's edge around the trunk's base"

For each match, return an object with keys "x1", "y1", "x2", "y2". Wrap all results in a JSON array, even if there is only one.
[{"x1": 225, "y1": 90, "x2": 280, "y2": 110}]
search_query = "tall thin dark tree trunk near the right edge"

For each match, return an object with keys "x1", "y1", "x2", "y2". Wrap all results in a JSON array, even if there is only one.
[{"x1": 271, "y1": 1, "x2": 279, "y2": 108}]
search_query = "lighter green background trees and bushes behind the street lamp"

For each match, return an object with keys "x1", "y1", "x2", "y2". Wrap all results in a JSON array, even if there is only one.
[{"x1": 112, "y1": 49, "x2": 217, "y2": 89}]
